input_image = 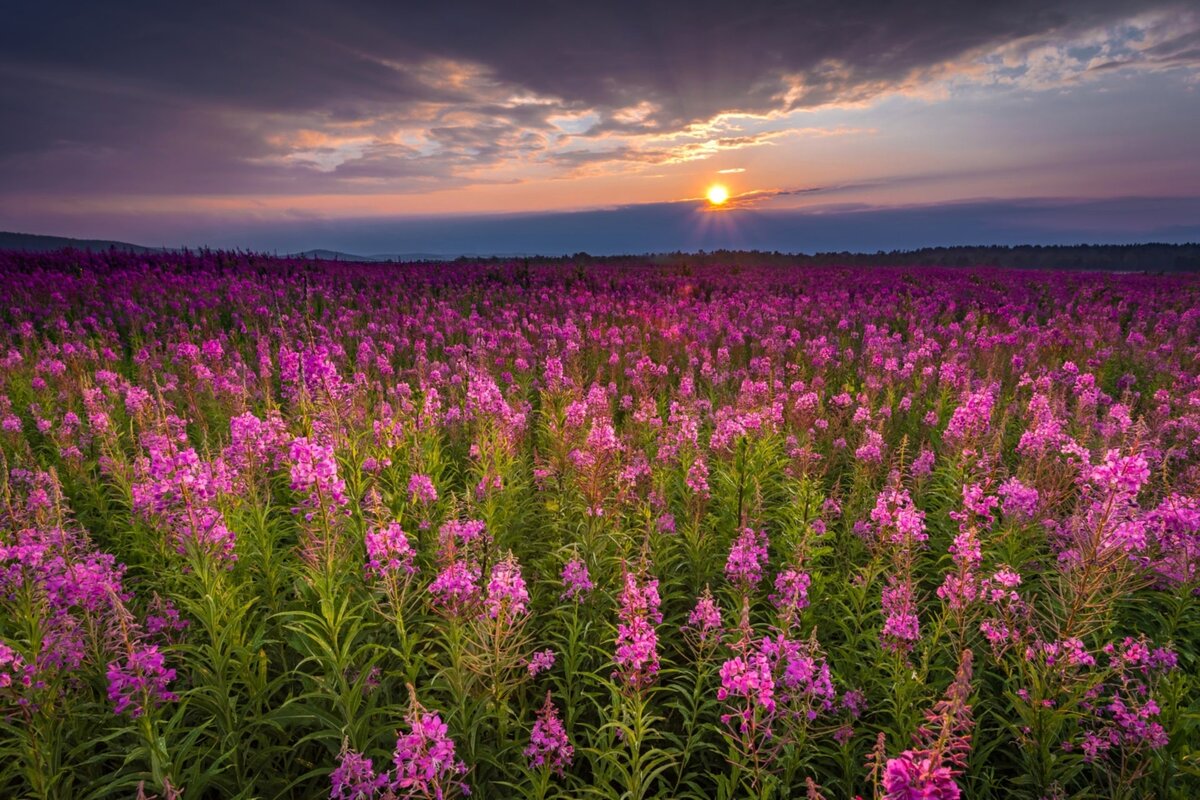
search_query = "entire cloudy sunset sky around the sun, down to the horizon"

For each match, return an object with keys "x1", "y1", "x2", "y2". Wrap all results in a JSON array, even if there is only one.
[{"x1": 0, "y1": 0, "x2": 1200, "y2": 254}]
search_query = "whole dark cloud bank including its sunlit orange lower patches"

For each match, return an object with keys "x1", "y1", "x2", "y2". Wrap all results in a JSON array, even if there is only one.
[{"x1": 0, "y1": 0, "x2": 1194, "y2": 193}]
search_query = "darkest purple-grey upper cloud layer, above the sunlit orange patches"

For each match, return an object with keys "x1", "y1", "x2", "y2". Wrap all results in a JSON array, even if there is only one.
[{"x1": 0, "y1": 0, "x2": 1180, "y2": 124}]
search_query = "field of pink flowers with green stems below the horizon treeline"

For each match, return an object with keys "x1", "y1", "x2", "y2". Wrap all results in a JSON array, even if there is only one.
[{"x1": 0, "y1": 253, "x2": 1200, "y2": 800}]
